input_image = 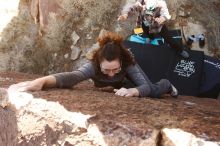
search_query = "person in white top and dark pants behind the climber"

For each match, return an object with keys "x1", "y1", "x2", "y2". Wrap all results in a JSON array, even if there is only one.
[{"x1": 118, "y1": 0, "x2": 189, "y2": 58}]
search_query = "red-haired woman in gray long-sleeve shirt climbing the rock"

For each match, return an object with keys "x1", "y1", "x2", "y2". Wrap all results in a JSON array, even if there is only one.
[{"x1": 9, "y1": 32, "x2": 178, "y2": 97}]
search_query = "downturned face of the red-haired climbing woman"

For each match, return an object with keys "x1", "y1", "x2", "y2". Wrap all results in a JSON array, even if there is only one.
[{"x1": 100, "y1": 59, "x2": 121, "y2": 77}]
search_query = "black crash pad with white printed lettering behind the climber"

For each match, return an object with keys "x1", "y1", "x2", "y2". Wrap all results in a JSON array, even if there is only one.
[{"x1": 124, "y1": 41, "x2": 204, "y2": 96}]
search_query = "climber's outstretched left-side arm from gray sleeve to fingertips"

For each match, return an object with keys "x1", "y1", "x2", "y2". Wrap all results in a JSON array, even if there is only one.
[{"x1": 9, "y1": 63, "x2": 95, "y2": 91}]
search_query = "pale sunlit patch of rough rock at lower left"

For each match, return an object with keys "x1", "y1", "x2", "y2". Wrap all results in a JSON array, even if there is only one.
[{"x1": 15, "y1": 99, "x2": 90, "y2": 146}]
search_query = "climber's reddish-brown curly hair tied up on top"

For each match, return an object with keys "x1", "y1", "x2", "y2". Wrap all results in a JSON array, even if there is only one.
[{"x1": 92, "y1": 32, "x2": 135, "y2": 68}]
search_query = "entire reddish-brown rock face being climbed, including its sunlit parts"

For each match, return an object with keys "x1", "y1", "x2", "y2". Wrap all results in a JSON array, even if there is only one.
[{"x1": 0, "y1": 73, "x2": 220, "y2": 146}]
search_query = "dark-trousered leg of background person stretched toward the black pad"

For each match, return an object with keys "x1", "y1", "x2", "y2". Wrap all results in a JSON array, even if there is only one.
[{"x1": 159, "y1": 25, "x2": 189, "y2": 58}]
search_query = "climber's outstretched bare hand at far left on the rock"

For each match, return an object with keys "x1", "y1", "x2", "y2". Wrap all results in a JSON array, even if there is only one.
[{"x1": 8, "y1": 78, "x2": 44, "y2": 91}]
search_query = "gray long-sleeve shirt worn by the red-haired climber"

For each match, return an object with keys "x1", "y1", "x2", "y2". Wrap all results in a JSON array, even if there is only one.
[{"x1": 54, "y1": 62, "x2": 152, "y2": 97}]
